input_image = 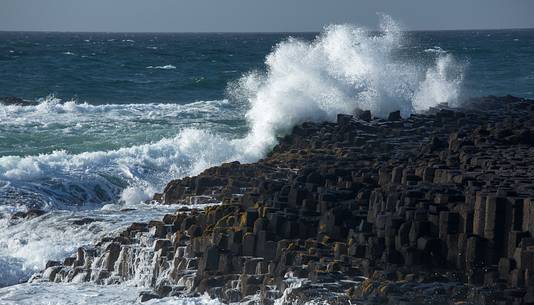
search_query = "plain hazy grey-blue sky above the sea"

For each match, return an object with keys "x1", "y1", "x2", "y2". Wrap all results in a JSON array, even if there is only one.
[{"x1": 0, "y1": 0, "x2": 534, "y2": 32}]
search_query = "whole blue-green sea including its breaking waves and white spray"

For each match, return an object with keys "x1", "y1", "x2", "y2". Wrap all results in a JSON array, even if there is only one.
[{"x1": 0, "y1": 18, "x2": 534, "y2": 304}]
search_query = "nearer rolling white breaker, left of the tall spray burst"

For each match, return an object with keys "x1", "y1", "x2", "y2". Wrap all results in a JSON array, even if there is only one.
[{"x1": 0, "y1": 129, "x2": 246, "y2": 209}]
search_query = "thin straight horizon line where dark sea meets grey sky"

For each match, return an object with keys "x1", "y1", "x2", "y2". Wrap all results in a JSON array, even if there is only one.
[{"x1": 0, "y1": 27, "x2": 534, "y2": 34}]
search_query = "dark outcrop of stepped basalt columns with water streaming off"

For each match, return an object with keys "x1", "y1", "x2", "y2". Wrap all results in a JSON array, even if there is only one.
[{"x1": 33, "y1": 96, "x2": 534, "y2": 304}]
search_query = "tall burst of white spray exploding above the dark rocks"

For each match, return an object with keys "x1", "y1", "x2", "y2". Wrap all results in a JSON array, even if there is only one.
[{"x1": 234, "y1": 16, "x2": 462, "y2": 153}]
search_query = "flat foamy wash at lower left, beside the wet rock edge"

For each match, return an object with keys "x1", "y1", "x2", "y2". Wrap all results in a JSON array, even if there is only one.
[{"x1": 0, "y1": 204, "x2": 213, "y2": 287}]
